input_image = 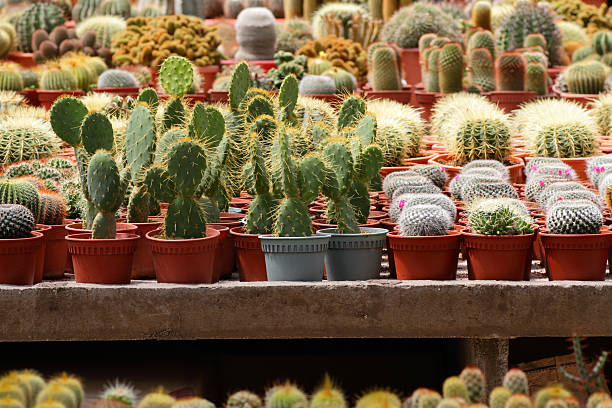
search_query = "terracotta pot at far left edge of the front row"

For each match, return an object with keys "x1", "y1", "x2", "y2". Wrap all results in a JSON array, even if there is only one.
[{"x1": 0, "y1": 231, "x2": 44, "y2": 285}]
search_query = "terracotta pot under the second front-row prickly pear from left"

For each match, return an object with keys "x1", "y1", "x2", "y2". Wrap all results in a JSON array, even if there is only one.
[{"x1": 146, "y1": 227, "x2": 220, "y2": 283}]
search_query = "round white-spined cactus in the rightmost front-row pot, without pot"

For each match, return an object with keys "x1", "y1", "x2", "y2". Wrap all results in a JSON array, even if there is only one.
[{"x1": 536, "y1": 200, "x2": 603, "y2": 234}]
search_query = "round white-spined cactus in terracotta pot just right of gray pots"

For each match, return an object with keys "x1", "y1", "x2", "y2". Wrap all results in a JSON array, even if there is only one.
[{"x1": 387, "y1": 193, "x2": 461, "y2": 280}]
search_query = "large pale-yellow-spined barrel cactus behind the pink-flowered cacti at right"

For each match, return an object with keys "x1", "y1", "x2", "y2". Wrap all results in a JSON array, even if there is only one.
[{"x1": 513, "y1": 99, "x2": 599, "y2": 158}]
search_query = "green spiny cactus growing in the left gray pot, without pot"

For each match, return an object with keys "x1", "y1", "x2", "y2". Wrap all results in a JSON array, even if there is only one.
[{"x1": 272, "y1": 128, "x2": 325, "y2": 237}]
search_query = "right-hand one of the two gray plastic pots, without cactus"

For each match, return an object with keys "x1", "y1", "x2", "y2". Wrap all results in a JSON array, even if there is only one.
[{"x1": 317, "y1": 227, "x2": 389, "y2": 280}]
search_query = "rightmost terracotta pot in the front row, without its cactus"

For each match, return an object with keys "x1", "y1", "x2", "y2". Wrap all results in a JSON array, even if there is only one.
[{"x1": 540, "y1": 227, "x2": 612, "y2": 281}]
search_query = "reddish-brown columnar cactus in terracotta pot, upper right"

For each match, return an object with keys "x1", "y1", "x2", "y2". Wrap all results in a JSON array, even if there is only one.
[{"x1": 487, "y1": 51, "x2": 535, "y2": 113}]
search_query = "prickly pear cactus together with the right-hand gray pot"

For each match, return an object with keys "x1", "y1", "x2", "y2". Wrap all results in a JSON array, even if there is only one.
[{"x1": 317, "y1": 113, "x2": 387, "y2": 280}]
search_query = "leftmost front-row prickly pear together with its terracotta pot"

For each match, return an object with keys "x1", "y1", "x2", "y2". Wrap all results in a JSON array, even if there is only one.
[{"x1": 66, "y1": 111, "x2": 139, "y2": 284}]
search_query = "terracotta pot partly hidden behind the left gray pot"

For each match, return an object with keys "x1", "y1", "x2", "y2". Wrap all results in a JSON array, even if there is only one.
[{"x1": 230, "y1": 227, "x2": 268, "y2": 282}]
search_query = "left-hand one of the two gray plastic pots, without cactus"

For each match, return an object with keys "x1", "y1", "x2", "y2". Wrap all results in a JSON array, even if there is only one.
[{"x1": 259, "y1": 235, "x2": 329, "y2": 281}]
